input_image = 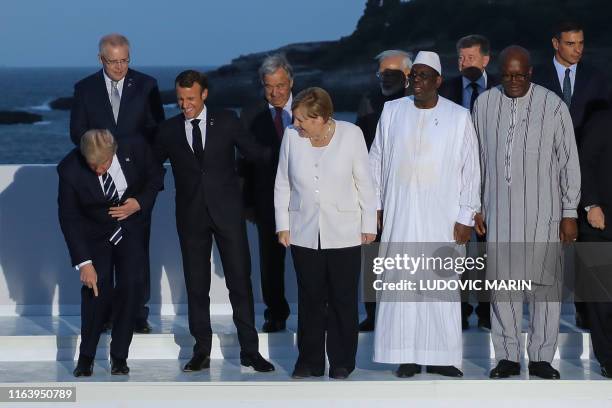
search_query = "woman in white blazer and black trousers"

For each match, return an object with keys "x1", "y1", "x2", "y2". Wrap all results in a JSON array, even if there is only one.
[{"x1": 274, "y1": 88, "x2": 376, "y2": 379}]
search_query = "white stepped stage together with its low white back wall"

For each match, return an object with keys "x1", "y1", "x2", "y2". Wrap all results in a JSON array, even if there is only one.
[{"x1": 0, "y1": 165, "x2": 612, "y2": 408}]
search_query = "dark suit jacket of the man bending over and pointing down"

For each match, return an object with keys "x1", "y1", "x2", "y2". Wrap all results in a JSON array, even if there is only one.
[{"x1": 57, "y1": 141, "x2": 164, "y2": 265}]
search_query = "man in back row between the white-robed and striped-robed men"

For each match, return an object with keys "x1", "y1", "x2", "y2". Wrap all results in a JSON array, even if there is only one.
[{"x1": 440, "y1": 34, "x2": 499, "y2": 330}]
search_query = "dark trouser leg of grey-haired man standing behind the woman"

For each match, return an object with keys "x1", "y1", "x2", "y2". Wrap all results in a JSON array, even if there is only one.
[{"x1": 255, "y1": 200, "x2": 290, "y2": 321}]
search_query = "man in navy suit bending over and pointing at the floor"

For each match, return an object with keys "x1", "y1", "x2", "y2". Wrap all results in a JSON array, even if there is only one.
[{"x1": 57, "y1": 129, "x2": 163, "y2": 377}]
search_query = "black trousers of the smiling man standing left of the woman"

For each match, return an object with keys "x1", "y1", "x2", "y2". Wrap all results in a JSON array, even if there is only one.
[{"x1": 179, "y1": 206, "x2": 259, "y2": 355}]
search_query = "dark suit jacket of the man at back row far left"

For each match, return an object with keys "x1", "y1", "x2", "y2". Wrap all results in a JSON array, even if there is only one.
[{"x1": 70, "y1": 69, "x2": 164, "y2": 145}]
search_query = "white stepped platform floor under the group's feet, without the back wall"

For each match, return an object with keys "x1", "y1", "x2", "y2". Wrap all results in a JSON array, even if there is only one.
[{"x1": 0, "y1": 315, "x2": 612, "y2": 408}]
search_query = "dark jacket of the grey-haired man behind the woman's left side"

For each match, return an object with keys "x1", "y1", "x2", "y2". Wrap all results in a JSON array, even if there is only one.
[{"x1": 240, "y1": 99, "x2": 281, "y2": 208}]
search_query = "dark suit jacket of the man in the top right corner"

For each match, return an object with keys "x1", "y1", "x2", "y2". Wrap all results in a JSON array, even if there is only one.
[{"x1": 533, "y1": 61, "x2": 610, "y2": 142}]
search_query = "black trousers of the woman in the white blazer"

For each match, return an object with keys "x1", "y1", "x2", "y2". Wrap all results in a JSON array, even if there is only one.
[{"x1": 291, "y1": 245, "x2": 361, "y2": 375}]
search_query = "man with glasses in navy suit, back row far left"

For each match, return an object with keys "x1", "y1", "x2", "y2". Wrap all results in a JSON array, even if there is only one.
[{"x1": 70, "y1": 34, "x2": 164, "y2": 333}]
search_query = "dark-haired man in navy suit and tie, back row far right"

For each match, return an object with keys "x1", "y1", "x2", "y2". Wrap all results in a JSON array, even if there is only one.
[{"x1": 533, "y1": 22, "x2": 610, "y2": 329}]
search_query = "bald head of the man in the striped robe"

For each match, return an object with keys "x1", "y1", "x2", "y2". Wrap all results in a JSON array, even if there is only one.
[{"x1": 499, "y1": 45, "x2": 532, "y2": 98}]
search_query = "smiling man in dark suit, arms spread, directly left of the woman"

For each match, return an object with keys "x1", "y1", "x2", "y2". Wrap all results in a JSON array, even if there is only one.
[{"x1": 155, "y1": 70, "x2": 274, "y2": 371}]
